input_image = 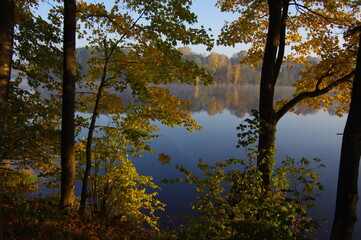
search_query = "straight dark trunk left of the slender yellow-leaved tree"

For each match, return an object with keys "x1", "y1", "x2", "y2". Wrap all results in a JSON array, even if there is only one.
[{"x1": 60, "y1": 0, "x2": 76, "y2": 208}]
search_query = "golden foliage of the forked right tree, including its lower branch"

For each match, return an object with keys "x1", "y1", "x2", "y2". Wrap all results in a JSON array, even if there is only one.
[{"x1": 217, "y1": 0, "x2": 360, "y2": 115}]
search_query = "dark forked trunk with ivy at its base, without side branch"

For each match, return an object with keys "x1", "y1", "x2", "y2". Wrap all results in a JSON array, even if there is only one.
[{"x1": 257, "y1": 0, "x2": 283, "y2": 189}]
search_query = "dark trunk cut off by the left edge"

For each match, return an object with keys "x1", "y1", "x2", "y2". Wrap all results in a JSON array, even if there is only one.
[{"x1": 0, "y1": 0, "x2": 15, "y2": 120}]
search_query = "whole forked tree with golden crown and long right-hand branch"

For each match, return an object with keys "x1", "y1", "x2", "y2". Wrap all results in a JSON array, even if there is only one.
[{"x1": 217, "y1": 0, "x2": 359, "y2": 189}]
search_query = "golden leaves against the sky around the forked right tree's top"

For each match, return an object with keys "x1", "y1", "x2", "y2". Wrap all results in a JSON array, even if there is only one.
[{"x1": 217, "y1": 0, "x2": 360, "y2": 62}]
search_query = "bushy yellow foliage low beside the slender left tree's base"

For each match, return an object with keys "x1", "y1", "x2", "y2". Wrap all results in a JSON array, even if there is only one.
[{"x1": 77, "y1": 128, "x2": 164, "y2": 229}]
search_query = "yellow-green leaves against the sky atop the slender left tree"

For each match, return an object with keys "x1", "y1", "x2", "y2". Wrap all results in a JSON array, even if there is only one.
[{"x1": 79, "y1": 0, "x2": 213, "y2": 48}]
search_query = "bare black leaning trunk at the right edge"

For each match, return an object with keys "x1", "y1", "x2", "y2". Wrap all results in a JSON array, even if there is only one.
[{"x1": 331, "y1": 33, "x2": 361, "y2": 240}]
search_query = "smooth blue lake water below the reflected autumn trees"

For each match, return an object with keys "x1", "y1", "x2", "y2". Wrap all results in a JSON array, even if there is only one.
[{"x1": 135, "y1": 110, "x2": 361, "y2": 239}]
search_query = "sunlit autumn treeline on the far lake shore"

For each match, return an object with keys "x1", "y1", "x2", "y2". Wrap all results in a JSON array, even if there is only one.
[{"x1": 77, "y1": 47, "x2": 317, "y2": 86}]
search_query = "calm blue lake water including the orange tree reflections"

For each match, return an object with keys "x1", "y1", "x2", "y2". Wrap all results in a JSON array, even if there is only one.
[{"x1": 126, "y1": 85, "x2": 361, "y2": 239}]
